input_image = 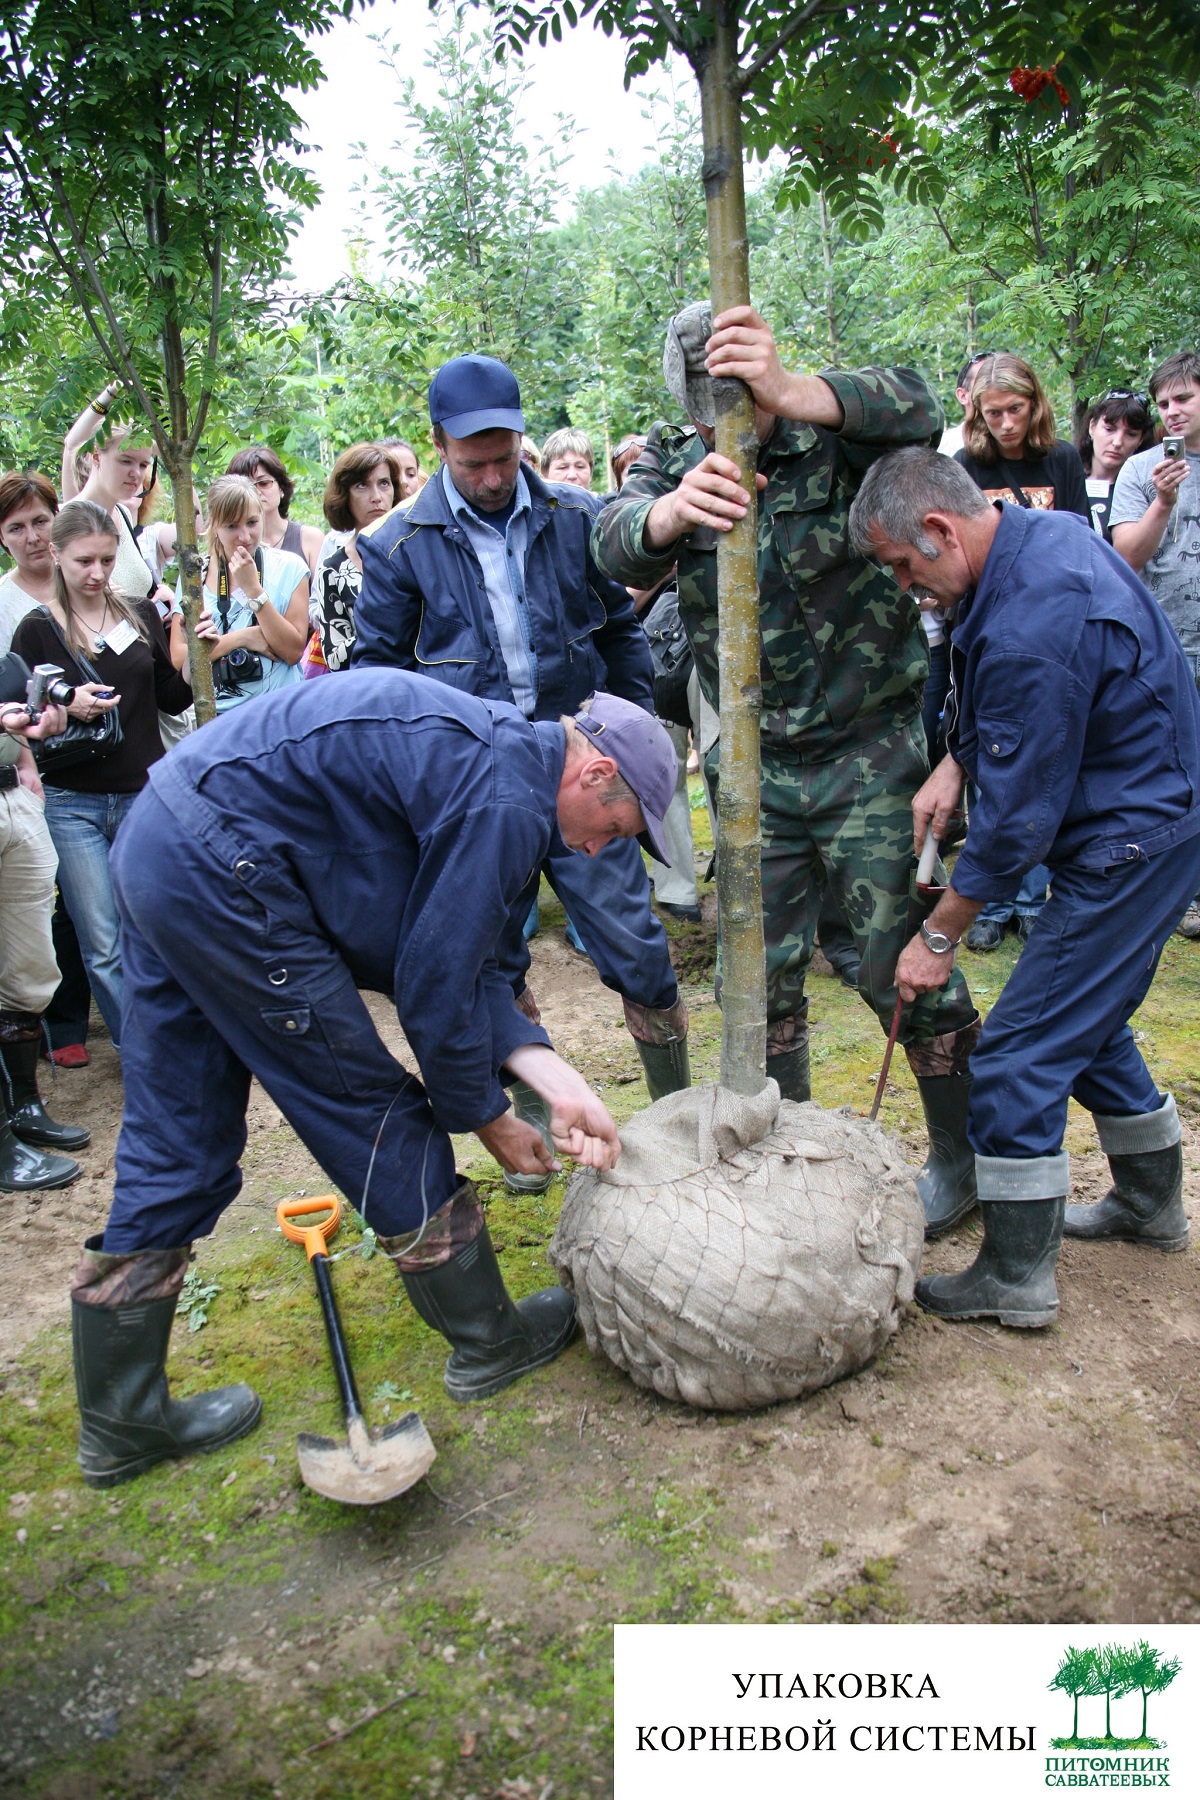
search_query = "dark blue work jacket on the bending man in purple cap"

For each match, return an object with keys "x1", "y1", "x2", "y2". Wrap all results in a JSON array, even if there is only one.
[{"x1": 149, "y1": 670, "x2": 565, "y2": 1132}]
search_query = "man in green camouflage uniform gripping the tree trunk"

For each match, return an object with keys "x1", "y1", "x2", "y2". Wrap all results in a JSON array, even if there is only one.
[{"x1": 592, "y1": 304, "x2": 979, "y2": 1235}]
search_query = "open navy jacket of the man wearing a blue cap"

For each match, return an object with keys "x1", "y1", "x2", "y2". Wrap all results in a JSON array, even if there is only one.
[{"x1": 353, "y1": 468, "x2": 655, "y2": 718}]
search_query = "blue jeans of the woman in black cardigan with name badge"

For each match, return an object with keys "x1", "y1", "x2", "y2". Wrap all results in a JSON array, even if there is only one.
[{"x1": 45, "y1": 783, "x2": 137, "y2": 1046}]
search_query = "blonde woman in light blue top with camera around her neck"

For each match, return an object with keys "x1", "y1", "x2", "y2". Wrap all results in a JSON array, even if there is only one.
[{"x1": 196, "y1": 475, "x2": 309, "y2": 713}]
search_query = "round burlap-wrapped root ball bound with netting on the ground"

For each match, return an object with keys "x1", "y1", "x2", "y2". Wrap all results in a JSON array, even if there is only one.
[{"x1": 551, "y1": 1082, "x2": 925, "y2": 1411}]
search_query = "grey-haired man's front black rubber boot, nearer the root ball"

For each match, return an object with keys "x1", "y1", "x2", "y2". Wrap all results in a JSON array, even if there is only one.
[{"x1": 916, "y1": 1199, "x2": 1067, "y2": 1328}]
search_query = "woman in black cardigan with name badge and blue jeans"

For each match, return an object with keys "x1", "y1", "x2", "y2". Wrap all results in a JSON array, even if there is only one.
[{"x1": 13, "y1": 500, "x2": 193, "y2": 1046}]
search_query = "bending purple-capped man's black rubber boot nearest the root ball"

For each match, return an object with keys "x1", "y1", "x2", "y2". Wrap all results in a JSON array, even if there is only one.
[{"x1": 401, "y1": 1226, "x2": 576, "y2": 1400}]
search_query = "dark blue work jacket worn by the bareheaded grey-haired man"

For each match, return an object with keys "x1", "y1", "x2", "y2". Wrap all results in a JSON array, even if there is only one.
[{"x1": 946, "y1": 506, "x2": 1200, "y2": 900}]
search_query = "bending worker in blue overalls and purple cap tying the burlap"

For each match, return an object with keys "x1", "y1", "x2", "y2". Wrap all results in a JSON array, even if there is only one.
[{"x1": 72, "y1": 670, "x2": 675, "y2": 1487}]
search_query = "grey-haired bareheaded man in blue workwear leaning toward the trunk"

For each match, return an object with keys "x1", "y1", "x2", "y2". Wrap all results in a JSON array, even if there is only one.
[{"x1": 851, "y1": 450, "x2": 1200, "y2": 1325}]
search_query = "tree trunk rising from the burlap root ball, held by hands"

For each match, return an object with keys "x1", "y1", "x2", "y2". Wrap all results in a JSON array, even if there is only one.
[{"x1": 694, "y1": 0, "x2": 766, "y2": 1094}]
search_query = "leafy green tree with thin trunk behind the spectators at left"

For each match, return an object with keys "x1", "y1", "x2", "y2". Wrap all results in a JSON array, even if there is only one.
[{"x1": 0, "y1": 0, "x2": 361, "y2": 716}]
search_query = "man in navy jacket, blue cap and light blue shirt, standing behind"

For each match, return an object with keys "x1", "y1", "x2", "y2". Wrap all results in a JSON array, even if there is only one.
[{"x1": 354, "y1": 356, "x2": 689, "y2": 1144}]
